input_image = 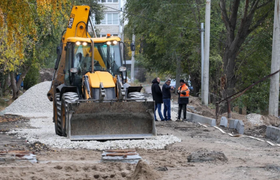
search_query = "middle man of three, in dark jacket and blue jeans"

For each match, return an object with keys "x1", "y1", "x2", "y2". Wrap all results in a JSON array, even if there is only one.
[{"x1": 162, "y1": 79, "x2": 173, "y2": 121}]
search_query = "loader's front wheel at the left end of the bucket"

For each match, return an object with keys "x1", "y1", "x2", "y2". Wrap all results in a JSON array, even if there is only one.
[{"x1": 57, "y1": 92, "x2": 79, "y2": 137}]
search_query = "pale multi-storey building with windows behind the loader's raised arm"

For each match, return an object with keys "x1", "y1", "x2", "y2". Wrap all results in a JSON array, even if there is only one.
[{"x1": 96, "y1": 0, "x2": 121, "y2": 37}]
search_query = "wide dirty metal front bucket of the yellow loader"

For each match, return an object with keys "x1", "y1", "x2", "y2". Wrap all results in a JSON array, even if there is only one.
[{"x1": 67, "y1": 101, "x2": 156, "y2": 140}]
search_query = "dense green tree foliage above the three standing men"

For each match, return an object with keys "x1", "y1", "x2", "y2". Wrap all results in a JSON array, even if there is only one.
[{"x1": 126, "y1": 0, "x2": 205, "y2": 91}]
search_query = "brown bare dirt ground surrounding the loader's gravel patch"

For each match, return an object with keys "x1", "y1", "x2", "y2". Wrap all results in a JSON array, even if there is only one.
[{"x1": 0, "y1": 116, "x2": 280, "y2": 180}]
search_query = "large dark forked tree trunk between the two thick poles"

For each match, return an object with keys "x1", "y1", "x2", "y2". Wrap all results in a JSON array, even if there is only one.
[{"x1": 220, "y1": 0, "x2": 273, "y2": 98}]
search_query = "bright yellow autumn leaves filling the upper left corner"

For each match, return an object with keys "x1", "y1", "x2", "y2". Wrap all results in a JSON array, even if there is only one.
[{"x1": 0, "y1": 0, "x2": 71, "y2": 71}]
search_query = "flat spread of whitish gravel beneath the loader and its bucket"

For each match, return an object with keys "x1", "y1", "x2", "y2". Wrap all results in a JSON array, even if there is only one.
[{"x1": 9, "y1": 117, "x2": 181, "y2": 150}]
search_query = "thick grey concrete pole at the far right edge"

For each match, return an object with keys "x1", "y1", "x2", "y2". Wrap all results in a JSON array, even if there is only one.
[{"x1": 269, "y1": 0, "x2": 280, "y2": 117}]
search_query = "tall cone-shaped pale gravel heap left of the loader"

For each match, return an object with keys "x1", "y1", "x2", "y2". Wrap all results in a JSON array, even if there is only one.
[{"x1": 4, "y1": 81, "x2": 53, "y2": 117}]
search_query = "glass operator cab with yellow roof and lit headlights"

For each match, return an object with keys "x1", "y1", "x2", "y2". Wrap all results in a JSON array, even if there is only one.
[{"x1": 64, "y1": 37, "x2": 126, "y2": 93}]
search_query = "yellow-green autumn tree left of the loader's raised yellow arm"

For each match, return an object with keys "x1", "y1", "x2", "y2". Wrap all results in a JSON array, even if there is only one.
[{"x1": 0, "y1": 0, "x2": 102, "y2": 99}]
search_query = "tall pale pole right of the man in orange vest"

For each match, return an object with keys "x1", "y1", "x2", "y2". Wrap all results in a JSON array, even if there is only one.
[{"x1": 202, "y1": 0, "x2": 211, "y2": 105}]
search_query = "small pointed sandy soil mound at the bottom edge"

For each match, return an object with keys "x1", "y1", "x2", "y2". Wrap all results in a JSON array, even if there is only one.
[{"x1": 128, "y1": 160, "x2": 160, "y2": 180}]
